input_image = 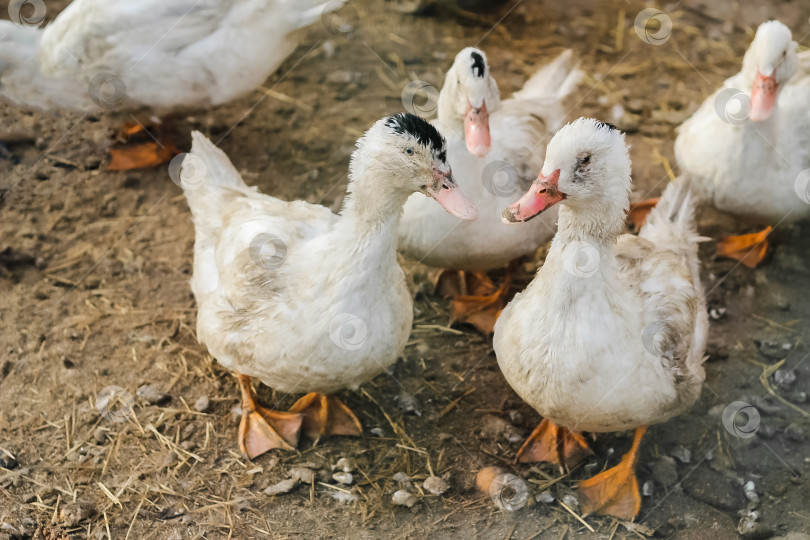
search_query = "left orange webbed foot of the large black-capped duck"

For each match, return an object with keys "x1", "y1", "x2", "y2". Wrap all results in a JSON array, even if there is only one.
[{"x1": 236, "y1": 373, "x2": 304, "y2": 459}]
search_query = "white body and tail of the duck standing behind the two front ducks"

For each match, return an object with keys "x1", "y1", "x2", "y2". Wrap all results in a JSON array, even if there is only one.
[{"x1": 399, "y1": 50, "x2": 582, "y2": 270}]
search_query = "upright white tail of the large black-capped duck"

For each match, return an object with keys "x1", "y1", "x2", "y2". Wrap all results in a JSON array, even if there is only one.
[{"x1": 181, "y1": 131, "x2": 249, "y2": 218}]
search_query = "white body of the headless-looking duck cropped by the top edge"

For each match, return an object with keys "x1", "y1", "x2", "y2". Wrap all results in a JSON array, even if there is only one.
[{"x1": 0, "y1": 0, "x2": 342, "y2": 168}]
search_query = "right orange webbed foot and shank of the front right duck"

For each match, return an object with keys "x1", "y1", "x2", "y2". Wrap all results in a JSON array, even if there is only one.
[{"x1": 579, "y1": 426, "x2": 647, "y2": 520}]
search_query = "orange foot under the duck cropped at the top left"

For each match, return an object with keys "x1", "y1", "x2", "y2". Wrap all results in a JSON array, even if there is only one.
[{"x1": 107, "y1": 117, "x2": 180, "y2": 171}]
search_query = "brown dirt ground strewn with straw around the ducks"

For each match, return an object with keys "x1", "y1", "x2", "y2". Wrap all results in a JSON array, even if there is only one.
[{"x1": 0, "y1": 0, "x2": 810, "y2": 540}]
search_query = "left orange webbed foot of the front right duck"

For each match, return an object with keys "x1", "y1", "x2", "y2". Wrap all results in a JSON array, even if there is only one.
[{"x1": 517, "y1": 418, "x2": 591, "y2": 469}]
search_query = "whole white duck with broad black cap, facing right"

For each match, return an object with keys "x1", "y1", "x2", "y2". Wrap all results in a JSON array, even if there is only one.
[{"x1": 180, "y1": 114, "x2": 476, "y2": 457}]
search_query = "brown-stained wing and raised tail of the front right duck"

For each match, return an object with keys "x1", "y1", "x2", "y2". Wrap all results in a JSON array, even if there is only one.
[{"x1": 616, "y1": 180, "x2": 708, "y2": 386}]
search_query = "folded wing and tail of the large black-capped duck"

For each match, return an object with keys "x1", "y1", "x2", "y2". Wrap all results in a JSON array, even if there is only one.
[{"x1": 180, "y1": 132, "x2": 337, "y2": 312}]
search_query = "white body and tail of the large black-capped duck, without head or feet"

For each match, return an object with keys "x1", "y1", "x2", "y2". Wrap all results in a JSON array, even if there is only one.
[{"x1": 184, "y1": 132, "x2": 412, "y2": 393}]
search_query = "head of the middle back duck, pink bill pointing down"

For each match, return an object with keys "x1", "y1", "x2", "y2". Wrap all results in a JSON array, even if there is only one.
[{"x1": 439, "y1": 47, "x2": 501, "y2": 157}]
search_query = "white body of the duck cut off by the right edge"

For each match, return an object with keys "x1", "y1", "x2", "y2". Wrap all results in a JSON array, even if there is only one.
[{"x1": 675, "y1": 21, "x2": 810, "y2": 225}]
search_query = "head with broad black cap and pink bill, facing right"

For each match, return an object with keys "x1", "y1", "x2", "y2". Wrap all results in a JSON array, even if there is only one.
[{"x1": 350, "y1": 113, "x2": 478, "y2": 220}]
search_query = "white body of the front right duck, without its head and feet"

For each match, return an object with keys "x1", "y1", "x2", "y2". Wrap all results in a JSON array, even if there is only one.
[{"x1": 494, "y1": 120, "x2": 708, "y2": 432}]
